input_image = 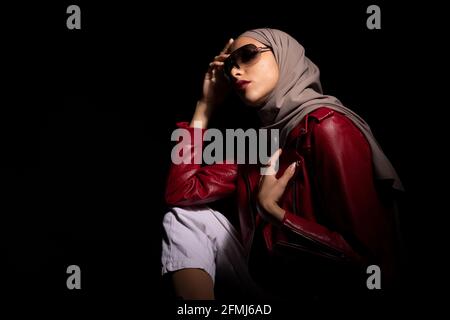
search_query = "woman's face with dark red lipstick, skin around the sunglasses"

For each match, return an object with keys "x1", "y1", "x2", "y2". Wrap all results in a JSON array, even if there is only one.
[{"x1": 230, "y1": 37, "x2": 279, "y2": 107}]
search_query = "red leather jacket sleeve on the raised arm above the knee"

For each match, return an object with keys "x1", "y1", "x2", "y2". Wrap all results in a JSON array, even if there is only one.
[{"x1": 165, "y1": 122, "x2": 237, "y2": 206}]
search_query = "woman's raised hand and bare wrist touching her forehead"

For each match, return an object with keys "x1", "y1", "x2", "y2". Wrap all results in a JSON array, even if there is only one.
[{"x1": 190, "y1": 39, "x2": 234, "y2": 128}]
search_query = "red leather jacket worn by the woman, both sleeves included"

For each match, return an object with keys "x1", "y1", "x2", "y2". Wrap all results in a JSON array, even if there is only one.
[{"x1": 166, "y1": 107, "x2": 394, "y2": 273}]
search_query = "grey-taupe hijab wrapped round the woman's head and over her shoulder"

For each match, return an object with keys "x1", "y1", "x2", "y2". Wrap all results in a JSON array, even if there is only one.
[{"x1": 240, "y1": 28, "x2": 403, "y2": 191}]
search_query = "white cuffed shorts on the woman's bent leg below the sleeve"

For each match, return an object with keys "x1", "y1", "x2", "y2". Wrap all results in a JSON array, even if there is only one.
[{"x1": 161, "y1": 206, "x2": 263, "y2": 298}]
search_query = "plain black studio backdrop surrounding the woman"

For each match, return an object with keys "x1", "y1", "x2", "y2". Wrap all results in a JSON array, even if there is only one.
[{"x1": 0, "y1": 0, "x2": 443, "y2": 313}]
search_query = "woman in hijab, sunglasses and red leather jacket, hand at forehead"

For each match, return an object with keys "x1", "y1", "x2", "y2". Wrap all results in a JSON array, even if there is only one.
[{"x1": 162, "y1": 29, "x2": 403, "y2": 299}]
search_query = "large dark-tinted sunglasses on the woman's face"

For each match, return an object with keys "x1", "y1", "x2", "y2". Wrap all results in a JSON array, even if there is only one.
[{"x1": 223, "y1": 44, "x2": 272, "y2": 81}]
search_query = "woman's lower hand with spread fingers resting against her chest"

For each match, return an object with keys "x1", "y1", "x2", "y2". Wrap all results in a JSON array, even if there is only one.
[{"x1": 257, "y1": 149, "x2": 296, "y2": 223}]
